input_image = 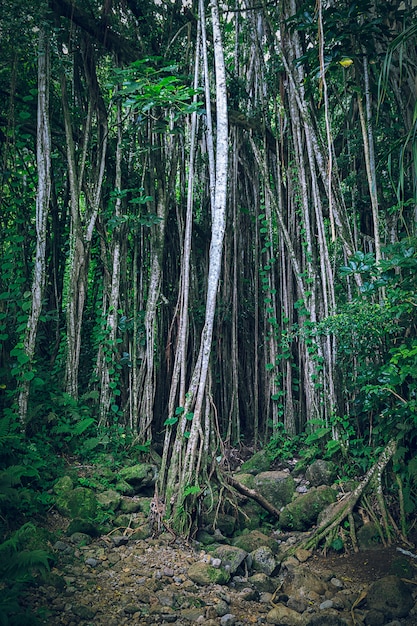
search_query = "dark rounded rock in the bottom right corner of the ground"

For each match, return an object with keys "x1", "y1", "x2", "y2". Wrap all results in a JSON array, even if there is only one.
[{"x1": 366, "y1": 575, "x2": 414, "y2": 618}]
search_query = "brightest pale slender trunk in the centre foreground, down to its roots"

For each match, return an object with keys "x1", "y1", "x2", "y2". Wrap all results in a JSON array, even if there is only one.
[{"x1": 162, "y1": 0, "x2": 228, "y2": 533}]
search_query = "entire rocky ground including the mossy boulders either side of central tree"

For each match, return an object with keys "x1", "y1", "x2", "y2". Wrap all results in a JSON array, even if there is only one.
[{"x1": 18, "y1": 454, "x2": 417, "y2": 626}]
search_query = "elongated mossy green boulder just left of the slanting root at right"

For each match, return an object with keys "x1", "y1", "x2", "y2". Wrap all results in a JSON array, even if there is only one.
[{"x1": 279, "y1": 486, "x2": 337, "y2": 531}]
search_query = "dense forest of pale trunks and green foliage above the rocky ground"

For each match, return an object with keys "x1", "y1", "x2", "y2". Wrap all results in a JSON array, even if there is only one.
[{"x1": 0, "y1": 0, "x2": 417, "y2": 620}]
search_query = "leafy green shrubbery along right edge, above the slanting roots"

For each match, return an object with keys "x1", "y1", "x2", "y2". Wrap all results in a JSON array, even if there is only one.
[{"x1": 320, "y1": 238, "x2": 417, "y2": 508}]
